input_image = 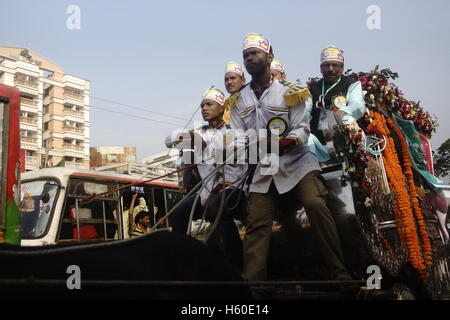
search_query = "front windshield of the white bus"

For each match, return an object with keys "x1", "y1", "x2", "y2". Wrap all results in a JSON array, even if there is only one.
[{"x1": 19, "y1": 180, "x2": 59, "y2": 239}]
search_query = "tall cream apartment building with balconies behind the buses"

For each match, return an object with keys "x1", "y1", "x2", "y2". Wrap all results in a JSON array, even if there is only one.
[{"x1": 0, "y1": 46, "x2": 89, "y2": 170}]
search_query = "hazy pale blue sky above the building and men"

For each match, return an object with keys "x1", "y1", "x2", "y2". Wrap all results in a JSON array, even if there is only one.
[{"x1": 0, "y1": 0, "x2": 450, "y2": 159}]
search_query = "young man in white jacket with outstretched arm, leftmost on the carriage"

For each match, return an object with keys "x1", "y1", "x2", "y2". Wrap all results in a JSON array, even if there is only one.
[{"x1": 166, "y1": 89, "x2": 247, "y2": 273}]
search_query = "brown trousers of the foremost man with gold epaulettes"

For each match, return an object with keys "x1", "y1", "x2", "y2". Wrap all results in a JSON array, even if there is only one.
[{"x1": 244, "y1": 170, "x2": 346, "y2": 281}]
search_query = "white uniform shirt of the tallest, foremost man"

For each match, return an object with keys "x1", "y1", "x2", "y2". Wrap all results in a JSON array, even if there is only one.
[{"x1": 231, "y1": 81, "x2": 320, "y2": 194}]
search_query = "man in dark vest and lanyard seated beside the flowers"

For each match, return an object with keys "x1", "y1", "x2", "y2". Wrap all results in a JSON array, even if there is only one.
[{"x1": 306, "y1": 46, "x2": 366, "y2": 162}]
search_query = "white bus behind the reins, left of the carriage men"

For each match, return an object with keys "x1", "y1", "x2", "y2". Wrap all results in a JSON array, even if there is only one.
[{"x1": 19, "y1": 167, "x2": 181, "y2": 246}]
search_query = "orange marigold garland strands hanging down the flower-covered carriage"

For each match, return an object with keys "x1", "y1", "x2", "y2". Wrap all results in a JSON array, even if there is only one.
[{"x1": 367, "y1": 111, "x2": 431, "y2": 278}]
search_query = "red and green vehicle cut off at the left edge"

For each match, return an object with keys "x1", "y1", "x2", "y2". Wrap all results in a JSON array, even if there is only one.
[{"x1": 0, "y1": 84, "x2": 20, "y2": 244}]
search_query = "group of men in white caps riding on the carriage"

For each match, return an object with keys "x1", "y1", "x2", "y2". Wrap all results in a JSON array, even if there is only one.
[{"x1": 130, "y1": 33, "x2": 365, "y2": 281}]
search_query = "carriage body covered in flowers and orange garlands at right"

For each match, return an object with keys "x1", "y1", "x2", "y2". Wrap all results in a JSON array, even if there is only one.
[{"x1": 294, "y1": 66, "x2": 450, "y2": 298}]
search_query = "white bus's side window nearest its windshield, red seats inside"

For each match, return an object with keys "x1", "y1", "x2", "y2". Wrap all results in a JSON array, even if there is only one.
[{"x1": 59, "y1": 179, "x2": 123, "y2": 242}]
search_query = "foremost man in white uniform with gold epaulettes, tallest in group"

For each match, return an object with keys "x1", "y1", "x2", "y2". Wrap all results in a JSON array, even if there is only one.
[{"x1": 227, "y1": 34, "x2": 351, "y2": 280}]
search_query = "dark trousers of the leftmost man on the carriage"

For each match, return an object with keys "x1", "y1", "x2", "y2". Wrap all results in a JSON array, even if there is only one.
[{"x1": 171, "y1": 189, "x2": 247, "y2": 273}]
